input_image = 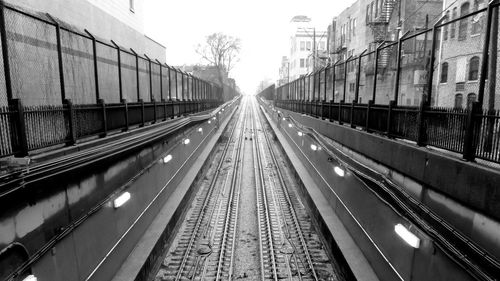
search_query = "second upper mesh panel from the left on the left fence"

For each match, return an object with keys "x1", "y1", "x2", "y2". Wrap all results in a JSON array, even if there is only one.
[{"x1": 61, "y1": 30, "x2": 96, "y2": 104}]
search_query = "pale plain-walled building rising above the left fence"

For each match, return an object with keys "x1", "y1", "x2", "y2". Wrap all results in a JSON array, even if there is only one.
[{"x1": 6, "y1": 0, "x2": 166, "y2": 62}]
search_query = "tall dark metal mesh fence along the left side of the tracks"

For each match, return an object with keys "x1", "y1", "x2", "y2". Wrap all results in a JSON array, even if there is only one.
[{"x1": 0, "y1": 1, "x2": 223, "y2": 157}]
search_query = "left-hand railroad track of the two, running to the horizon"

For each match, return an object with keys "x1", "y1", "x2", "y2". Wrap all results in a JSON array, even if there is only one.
[{"x1": 158, "y1": 97, "x2": 246, "y2": 280}]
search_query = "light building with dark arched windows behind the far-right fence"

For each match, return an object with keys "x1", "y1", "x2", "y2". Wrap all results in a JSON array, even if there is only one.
[{"x1": 433, "y1": 0, "x2": 500, "y2": 109}]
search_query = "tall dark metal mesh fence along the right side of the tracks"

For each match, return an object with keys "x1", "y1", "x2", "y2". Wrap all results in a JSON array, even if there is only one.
[{"x1": 267, "y1": 1, "x2": 500, "y2": 163}]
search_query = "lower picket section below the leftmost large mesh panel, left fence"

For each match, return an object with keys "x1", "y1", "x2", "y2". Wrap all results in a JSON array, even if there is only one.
[{"x1": 24, "y1": 105, "x2": 69, "y2": 150}]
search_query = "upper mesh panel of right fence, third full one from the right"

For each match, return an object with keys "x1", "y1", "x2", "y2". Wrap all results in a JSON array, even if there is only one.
[{"x1": 375, "y1": 43, "x2": 398, "y2": 104}]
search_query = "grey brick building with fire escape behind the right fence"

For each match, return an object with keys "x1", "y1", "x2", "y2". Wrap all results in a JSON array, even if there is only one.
[{"x1": 329, "y1": 0, "x2": 443, "y2": 105}]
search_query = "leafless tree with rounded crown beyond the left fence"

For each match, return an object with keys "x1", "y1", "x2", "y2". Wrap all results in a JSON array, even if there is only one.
[{"x1": 196, "y1": 33, "x2": 240, "y2": 85}]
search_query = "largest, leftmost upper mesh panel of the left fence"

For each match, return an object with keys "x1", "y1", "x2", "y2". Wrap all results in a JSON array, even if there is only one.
[{"x1": 5, "y1": 9, "x2": 62, "y2": 105}]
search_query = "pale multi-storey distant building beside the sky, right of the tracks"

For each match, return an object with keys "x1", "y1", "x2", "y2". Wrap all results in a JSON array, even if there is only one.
[{"x1": 289, "y1": 16, "x2": 328, "y2": 81}]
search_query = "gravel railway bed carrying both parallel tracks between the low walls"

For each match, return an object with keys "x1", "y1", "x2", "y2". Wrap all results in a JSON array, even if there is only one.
[{"x1": 152, "y1": 97, "x2": 344, "y2": 280}]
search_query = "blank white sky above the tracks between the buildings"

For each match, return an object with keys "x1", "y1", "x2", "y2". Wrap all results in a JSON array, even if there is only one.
[{"x1": 145, "y1": 0, "x2": 355, "y2": 94}]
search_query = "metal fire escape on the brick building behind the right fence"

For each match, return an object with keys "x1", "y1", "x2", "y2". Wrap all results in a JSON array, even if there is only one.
[{"x1": 367, "y1": 0, "x2": 397, "y2": 68}]
